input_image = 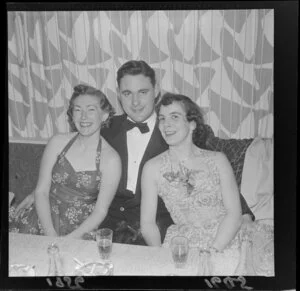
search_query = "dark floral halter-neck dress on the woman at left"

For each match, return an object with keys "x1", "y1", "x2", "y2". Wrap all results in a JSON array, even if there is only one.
[{"x1": 9, "y1": 134, "x2": 101, "y2": 239}]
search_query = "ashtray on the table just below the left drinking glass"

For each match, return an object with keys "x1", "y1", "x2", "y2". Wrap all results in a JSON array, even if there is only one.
[{"x1": 75, "y1": 262, "x2": 112, "y2": 276}]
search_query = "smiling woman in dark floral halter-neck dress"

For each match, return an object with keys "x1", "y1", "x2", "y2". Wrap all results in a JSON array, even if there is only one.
[{"x1": 9, "y1": 85, "x2": 121, "y2": 239}]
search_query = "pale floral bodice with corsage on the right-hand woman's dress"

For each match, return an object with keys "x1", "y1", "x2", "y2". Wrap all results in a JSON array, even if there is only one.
[{"x1": 159, "y1": 149, "x2": 225, "y2": 227}]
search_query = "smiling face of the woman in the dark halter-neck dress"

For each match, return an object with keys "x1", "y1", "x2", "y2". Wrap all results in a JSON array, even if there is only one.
[{"x1": 73, "y1": 95, "x2": 108, "y2": 136}]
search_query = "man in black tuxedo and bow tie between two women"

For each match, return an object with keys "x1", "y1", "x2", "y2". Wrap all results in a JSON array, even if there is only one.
[{"x1": 100, "y1": 61, "x2": 251, "y2": 244}]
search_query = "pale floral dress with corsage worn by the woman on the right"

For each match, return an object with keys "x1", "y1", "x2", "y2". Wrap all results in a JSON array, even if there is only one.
[{"x1": 158, "y1": 149, "x2": 274, "y2": 276}]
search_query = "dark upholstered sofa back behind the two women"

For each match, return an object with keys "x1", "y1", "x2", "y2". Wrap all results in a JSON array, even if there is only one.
[{"x1": 9, "y1": 125, "x2": 253, "y2": 203}]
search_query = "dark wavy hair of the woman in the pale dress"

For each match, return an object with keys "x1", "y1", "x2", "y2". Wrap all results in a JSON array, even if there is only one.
[{"x1": 156, "y1": 92, "x2": 207, "y2": 148}]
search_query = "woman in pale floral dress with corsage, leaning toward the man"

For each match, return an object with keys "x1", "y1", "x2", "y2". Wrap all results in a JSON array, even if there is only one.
[{"x1": 141, "y1": 93, "x2": 274, "y2": 276}]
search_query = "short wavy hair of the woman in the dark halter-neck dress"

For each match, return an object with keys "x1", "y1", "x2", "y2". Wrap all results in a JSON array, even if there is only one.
[{"x1": 67, "y1": 84, "x2": 115, "y2": 132}]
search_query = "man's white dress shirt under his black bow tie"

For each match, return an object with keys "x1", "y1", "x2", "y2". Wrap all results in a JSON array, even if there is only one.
[{"x1": 126, "y1": 112, "x2": 156, "y2": 194}]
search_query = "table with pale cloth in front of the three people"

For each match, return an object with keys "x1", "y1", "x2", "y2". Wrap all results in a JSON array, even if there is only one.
[{"x1": 9, "y1": 233, "x2": 199, "y2": 276}]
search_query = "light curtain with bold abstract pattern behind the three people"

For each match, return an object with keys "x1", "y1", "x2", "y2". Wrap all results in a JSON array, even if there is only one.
[{"x1": 8, "y1": 9, "x2": 274, "y2": 141}]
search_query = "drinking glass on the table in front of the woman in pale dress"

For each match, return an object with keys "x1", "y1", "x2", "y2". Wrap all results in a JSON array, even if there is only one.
[{"x1": 171, "y1": 236, "x2": 189, "y2": 268}]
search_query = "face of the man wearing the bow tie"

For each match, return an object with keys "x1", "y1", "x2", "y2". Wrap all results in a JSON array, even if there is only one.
[{"x1": 119, "y1": 74, "x2": 157, "y2": 122}]
